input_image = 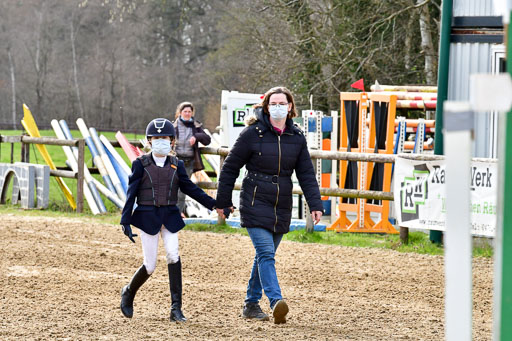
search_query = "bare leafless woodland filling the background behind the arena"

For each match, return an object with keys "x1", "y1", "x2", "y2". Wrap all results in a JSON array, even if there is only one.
[{"x1": 0, "y1": 0, "x2": 440, "y2": 132}]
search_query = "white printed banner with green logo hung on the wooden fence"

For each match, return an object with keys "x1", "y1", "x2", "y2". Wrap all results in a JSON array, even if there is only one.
[{"x1": 393, "y1": 157, "x2": 498, "y2": 237}]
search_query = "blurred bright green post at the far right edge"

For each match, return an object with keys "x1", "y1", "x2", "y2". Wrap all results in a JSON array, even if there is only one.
[{"x1": 495, "y1": 12, "x2": 512, "y2": 340}]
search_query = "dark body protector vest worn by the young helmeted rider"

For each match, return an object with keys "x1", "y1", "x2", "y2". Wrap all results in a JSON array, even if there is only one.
[{"x1": 137, "y1": 154, "x2": 179, "y2": 207}]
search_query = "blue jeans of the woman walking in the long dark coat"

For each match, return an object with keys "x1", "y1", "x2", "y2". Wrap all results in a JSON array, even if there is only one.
[{"x1": 245, "y1": 227, "x2": 283, "y2": 308}]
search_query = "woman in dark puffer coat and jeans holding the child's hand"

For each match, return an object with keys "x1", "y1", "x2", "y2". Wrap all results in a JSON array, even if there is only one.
[{"x1": 217, "y1": 87, "x2": 323, "y2": 324}]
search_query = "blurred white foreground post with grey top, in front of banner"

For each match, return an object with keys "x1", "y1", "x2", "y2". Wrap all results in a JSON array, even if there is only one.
[{"x1": 444, "y1": 101, "x2": 474, "y2": 341}]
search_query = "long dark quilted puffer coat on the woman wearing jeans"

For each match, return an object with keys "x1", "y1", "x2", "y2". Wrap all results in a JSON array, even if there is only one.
[{"x1": 217, "y1": 108, "x2": 323, "y2": 233}]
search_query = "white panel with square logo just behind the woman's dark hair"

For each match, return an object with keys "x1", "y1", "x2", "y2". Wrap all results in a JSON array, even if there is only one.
[{"x1": 220, "y1": 90, "x2": 262, "y2": 148}]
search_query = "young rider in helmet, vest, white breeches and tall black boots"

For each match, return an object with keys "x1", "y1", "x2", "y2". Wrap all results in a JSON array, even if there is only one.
[{"x1": 121, "y1": 118, "x2": 215, "y2": 322}]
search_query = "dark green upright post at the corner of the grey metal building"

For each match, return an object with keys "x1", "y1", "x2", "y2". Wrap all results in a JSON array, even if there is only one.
[{"x1": 430, "y1": 0, "x2": 453, "y2": 243}]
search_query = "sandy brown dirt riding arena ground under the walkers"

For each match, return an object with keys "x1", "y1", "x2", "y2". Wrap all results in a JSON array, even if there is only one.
[{"x1": 0, "y1": 214, "x2": 493, "y2": 340}]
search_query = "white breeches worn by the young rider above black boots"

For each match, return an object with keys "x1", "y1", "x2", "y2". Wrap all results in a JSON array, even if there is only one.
[{"x1": 139, "y1": 225, "x2": 180, "y2": 275}]
